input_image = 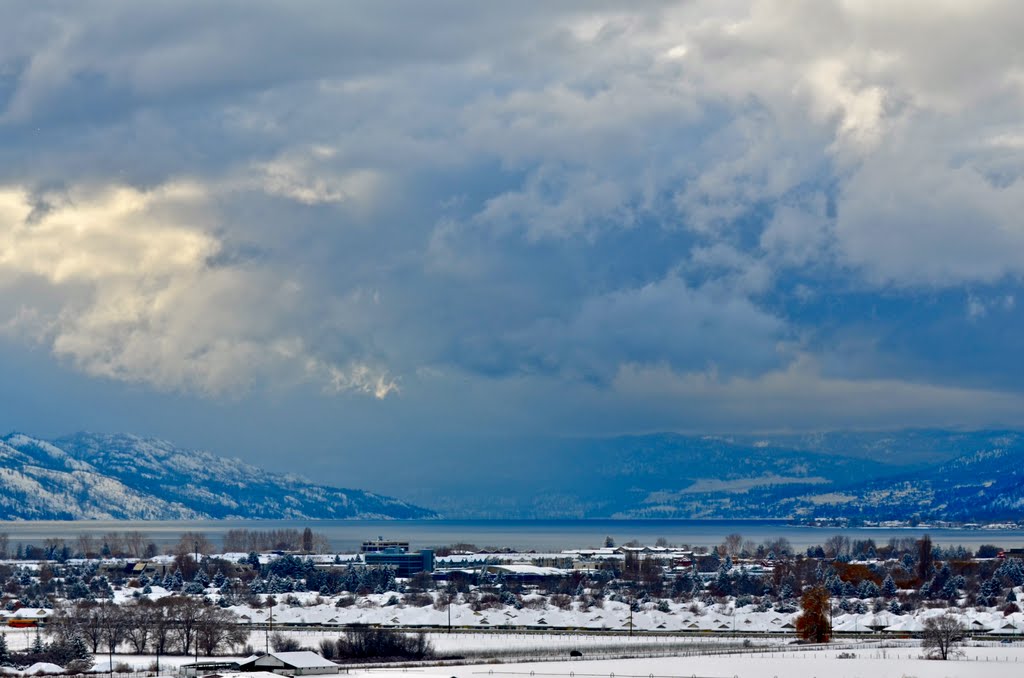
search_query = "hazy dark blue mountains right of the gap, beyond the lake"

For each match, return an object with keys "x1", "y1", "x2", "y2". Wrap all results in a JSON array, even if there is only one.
[{"x1": 407, "y1": 429, "x2": 1024, "y2": 520}]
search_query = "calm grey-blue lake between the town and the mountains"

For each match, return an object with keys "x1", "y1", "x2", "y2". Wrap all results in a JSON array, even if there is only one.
[{"x1": 0, "y1": 519, "x2": 1024, "y2": 552}]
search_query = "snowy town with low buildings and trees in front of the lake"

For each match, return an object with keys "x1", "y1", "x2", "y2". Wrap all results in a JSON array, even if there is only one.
[{"x1": 0, "y1": 527, "x2": 1024, "y2": 675}]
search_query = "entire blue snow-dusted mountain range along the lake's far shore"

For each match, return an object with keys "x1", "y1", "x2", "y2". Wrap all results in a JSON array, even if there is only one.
[{"x1": 0, "y1": 430, "x2": 1024, "y2": 521}]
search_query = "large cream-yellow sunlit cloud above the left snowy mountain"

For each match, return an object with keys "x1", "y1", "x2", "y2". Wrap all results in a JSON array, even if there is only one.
[{"x1": 0, "y1": 183, "x2": 395, "y2": 397}]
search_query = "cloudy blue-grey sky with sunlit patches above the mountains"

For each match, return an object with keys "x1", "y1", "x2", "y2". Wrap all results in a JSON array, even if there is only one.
[{"x1": 0, "y1": 0, "x2": 1024, "y2": 491}]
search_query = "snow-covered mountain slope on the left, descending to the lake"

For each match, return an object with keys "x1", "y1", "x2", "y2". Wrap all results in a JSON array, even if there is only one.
[{"x1": 0, "y1": 433, "x2": 434, "y2": 520}]
